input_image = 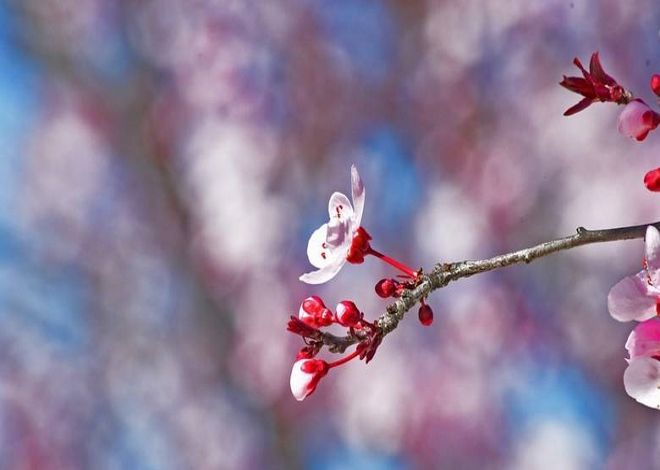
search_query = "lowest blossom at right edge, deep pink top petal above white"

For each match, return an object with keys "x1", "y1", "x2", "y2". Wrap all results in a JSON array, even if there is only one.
[{"x1": 623, "y1": 317, "x2": 660, "y2": 409}]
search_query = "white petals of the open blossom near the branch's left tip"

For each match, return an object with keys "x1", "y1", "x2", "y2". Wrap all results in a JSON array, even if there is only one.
[{"x1": 300, "y1": 165, "x2": 365, "y2": 284}]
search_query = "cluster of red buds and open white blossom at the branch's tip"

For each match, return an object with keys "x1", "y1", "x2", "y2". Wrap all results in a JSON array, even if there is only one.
[{"x1": 287, "y1": 166, "x2": 433, "y2": 400}]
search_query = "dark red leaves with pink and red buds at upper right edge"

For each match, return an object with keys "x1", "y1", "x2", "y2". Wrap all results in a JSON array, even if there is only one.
[{"x1": 559, "y1": 52, "x2": 660, "y2": 192}]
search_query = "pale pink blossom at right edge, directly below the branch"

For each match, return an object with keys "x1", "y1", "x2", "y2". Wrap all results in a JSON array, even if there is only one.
[{"x1": 607, "y1": 226, "x2": 660, "y2": 321}]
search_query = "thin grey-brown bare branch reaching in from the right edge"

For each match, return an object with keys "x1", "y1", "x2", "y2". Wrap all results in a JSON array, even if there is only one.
[{"x1": 318, "y1": 222, "x2": 660, "y2": 353}]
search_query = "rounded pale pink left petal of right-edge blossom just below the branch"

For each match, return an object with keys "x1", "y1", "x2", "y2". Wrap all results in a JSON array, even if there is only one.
[{"x1": 607, "y1": 271, "x2": 657, "y2": 321}]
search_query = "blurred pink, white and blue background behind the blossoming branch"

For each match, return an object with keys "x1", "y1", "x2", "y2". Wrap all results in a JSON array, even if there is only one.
[{"x1": 0, "y1": 0, "x2": 660, "y2": 469}]
